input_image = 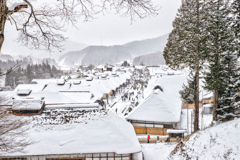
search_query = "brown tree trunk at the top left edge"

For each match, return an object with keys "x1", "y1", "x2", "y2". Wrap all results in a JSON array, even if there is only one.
[{"x1": 0, "y1": 0, "x2": 8, "y2": 52}]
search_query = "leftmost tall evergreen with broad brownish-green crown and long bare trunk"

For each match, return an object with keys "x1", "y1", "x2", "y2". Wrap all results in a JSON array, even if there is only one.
[{"x1": 164, "y1": 0, "x2": 206, "y2": 131}]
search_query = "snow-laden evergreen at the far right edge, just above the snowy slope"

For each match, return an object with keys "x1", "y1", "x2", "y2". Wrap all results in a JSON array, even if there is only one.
[{"x1": 216, "y1": 52, "x2": 240, "y2": 121}]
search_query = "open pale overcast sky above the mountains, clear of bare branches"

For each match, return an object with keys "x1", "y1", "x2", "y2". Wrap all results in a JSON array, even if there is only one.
[{"x1": 2, "y1": 0, "x2": 181, "y2": 58}]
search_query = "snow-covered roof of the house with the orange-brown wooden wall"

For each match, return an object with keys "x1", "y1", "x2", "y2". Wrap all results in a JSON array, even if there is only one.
[{"x1": 127, "y1": 76, "x2": 187, "y2": 123}]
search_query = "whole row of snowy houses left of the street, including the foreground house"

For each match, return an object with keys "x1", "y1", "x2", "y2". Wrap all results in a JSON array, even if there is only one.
[{"x1": 0, "y1": 69, "x2": 146, "y2": 160}]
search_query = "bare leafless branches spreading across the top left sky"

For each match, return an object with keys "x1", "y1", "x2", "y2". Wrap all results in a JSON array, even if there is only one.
[{"x1": 2, "y1": 0, "x2": 159, "y2": 51}]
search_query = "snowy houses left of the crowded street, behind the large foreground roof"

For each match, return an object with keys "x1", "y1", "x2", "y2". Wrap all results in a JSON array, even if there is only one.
[{"x1": 8, "y1": 72, "x2": 130, "y2": 114}]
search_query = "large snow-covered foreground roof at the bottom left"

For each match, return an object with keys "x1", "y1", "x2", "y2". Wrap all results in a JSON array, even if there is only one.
[{"x1": 1, "y1": 111, "x2": 141, "y2": 156}]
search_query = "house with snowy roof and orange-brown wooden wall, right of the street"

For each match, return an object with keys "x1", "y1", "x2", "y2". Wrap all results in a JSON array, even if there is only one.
[{"x1": 126, "y1": 76, "x2": 186, "y2": 135}]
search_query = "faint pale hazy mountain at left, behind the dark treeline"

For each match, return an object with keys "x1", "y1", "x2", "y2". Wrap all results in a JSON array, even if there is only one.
[{"x1": 2, "y1": 40, "x2": 88, "y2": 60}]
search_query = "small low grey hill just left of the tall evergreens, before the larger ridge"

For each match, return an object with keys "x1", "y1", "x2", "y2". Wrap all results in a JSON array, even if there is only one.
[{"x1": 133, "y1": 52, "x2": 165, "y2": 65}]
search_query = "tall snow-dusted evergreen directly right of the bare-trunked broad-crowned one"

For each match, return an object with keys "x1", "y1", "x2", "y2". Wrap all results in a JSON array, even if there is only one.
[{"x1": 205, "y1": 0, "x2": 234, "y2": 120}]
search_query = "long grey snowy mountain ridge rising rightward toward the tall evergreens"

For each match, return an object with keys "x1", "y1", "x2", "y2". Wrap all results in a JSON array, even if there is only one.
[{"x1": 59, "y1": 34, "x2": 168, "y2": 65}]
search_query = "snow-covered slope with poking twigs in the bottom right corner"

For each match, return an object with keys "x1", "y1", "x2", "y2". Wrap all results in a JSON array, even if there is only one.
[{"x1": 169, "y1": 119, "x2": 240, "y2": 160}]
